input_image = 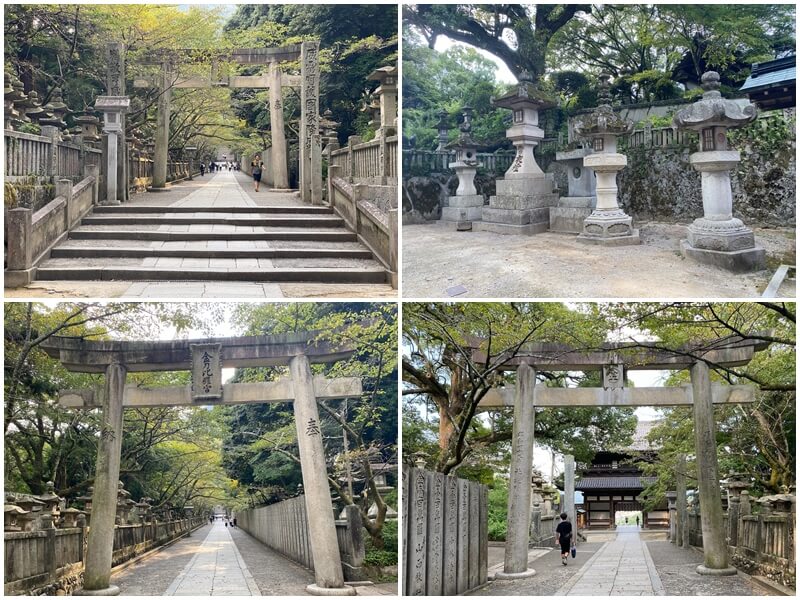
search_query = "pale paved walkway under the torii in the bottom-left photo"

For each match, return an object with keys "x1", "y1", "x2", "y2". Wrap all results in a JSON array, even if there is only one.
[{"x1": 164, "y1": 522, "x2": 261, "y2": 596}]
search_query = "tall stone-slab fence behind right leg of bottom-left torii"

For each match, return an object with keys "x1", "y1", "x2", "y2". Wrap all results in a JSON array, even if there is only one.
[{"x1": 236, "y1": 496, "x2": 366, "y2": 581}]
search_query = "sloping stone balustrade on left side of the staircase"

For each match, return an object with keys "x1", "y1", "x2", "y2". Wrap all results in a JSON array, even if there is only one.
[{"x1": 5, "y1": 165, "x2": 99, "y2": 287}]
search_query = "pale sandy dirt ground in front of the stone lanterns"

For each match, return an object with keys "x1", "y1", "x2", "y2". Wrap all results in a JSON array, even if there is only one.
[{"x1": 402, "y1": 223, "x2": 796, "y2": 299}]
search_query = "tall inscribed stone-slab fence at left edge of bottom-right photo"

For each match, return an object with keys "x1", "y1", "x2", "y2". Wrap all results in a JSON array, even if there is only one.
[{"x1": 402, "y1": 468, "x2": 489, "y2": 596}]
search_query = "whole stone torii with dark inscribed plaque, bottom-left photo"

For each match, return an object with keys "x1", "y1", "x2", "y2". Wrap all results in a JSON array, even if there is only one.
[{"x1": 42, "y1": 331, "x2": 361, "y2": 596}]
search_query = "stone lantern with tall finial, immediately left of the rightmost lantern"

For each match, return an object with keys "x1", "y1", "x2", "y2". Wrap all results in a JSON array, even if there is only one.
[{"x1": 575, "y1": 73, "x2": 640, "y2": 246}]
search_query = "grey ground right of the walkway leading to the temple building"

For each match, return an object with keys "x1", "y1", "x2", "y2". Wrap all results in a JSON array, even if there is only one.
[{"x1": 647, "y1": 542, "x2": 769, "y2": 596}]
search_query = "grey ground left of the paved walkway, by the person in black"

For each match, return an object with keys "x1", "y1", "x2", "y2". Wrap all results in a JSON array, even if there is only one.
[{"x1": 467, "y1": 542, "x2": 603, "y2": 596}]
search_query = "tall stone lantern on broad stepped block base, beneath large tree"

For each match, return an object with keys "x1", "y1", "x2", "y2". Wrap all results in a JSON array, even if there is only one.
[{"x1": 477, "y1": 72, "x2": 558, "y2": 235}]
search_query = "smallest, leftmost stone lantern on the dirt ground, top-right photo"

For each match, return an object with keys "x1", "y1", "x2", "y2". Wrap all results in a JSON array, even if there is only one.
[{"x1": 440, "y1": 106, "x2": 483, "y2": 230}]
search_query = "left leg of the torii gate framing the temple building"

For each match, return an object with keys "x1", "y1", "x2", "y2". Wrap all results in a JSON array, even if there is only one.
[{"x1": 497, "y1": 364, "x2": 536, "y2": 579}]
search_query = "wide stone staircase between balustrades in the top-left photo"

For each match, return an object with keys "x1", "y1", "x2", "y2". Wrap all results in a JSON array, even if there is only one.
[{"x1": 36, "y1": 204, "x2": 387, "y2": 283}]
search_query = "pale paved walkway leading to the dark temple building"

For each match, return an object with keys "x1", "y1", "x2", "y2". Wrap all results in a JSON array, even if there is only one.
[{"x1": 556, "y1": 525, "x2": 664, "y2": 596}]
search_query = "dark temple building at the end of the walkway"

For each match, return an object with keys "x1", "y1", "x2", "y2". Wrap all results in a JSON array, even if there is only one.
[{"x1": 575, "y1": 421, "x2": 669, "y2": 529}]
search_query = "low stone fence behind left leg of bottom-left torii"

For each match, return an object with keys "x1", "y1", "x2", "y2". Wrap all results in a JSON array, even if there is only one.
[{"x1": 4, "y1": 516, "x2": 207, "y2": 595}]
